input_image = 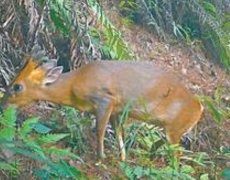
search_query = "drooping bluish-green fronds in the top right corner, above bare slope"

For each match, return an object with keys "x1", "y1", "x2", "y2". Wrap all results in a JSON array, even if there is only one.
[{"x1": 120, "y1": 0, "x2": 230, "y2": 70}]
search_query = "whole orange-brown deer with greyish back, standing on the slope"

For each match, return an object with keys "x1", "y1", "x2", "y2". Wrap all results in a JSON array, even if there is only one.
[{"x1": 0, "y1": 60, "x2": 203, "y2": 160}]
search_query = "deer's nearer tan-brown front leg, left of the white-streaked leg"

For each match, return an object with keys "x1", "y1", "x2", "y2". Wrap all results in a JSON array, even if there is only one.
[{"x1": 96, "y1": 98, "x2": 113, "y2": 159}]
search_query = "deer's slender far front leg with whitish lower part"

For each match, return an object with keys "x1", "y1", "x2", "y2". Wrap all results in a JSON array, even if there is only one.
[{"x1": 110, "y1": 115, "x2": 126, "y2": 161}]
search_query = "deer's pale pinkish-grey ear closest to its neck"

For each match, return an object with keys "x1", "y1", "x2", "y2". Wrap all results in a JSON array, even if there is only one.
[{"x1": 42, "y1": 66, "x2": 63, "y2": 85}]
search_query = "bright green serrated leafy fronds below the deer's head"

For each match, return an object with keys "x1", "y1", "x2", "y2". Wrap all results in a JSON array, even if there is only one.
[{"x1": 0, "y1": 107, "x2": 83, "y2": 179}]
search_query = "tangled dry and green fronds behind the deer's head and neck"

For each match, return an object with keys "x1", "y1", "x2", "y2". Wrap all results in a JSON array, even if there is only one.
[{"x1": 0, "y1": 0, "x2": 133, "y2": 85}]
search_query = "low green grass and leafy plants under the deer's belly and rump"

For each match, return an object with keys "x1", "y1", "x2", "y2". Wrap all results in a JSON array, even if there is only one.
[{"x1": 120, "y1": 121, "x2": 230, "y2": 179}]
